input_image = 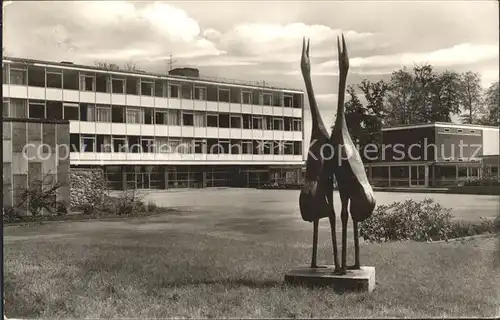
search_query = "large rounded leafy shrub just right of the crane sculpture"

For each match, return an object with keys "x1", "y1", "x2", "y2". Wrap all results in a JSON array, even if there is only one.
[{"x1": 359, "y1": 199, "x2": 452, "y2": 242}]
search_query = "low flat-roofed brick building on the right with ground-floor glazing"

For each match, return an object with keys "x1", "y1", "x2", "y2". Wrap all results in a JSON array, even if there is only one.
[{"x1": 366, "y1": 123, "x2": 500, "y2": 187}]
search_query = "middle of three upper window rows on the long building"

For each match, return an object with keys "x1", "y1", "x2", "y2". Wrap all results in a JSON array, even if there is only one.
[{"x1": 3, "y1": 98, "x2": 302, "y2": 131}]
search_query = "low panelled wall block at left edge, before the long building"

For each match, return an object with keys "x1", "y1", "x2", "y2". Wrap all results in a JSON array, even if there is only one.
[{"x1": 2, "y1": 118, "x2": 70, "y2": 213}]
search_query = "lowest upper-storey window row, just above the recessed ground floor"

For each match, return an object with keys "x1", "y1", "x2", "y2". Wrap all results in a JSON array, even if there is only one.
[{"x1": 70, "y1": 134, "x2": 302, "y2": 155}]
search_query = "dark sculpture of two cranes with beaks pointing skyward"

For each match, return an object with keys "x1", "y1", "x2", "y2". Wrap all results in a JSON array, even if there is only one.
[{"x1": 299, "y1": 35, "x2": 376, "y2": 274}]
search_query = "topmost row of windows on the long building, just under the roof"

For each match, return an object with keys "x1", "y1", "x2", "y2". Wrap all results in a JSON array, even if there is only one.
[{"x1": 3, "y1": 64, "x2": 303, "y2": 108}]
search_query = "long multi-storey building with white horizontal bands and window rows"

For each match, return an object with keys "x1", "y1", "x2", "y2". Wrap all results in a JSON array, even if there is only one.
[{"x1": 3, "y1": 58, "x2": 304, "y2": 189}]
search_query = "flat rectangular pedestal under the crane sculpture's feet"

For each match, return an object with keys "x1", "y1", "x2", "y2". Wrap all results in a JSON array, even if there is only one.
[{"x1": 285, "y1": 266, "x2": 375, "y2": 292}]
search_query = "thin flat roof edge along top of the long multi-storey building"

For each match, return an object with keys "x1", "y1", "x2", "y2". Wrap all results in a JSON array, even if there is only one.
[{"x1": 2, "y1": 57, "x2": 304, "y2": 94}]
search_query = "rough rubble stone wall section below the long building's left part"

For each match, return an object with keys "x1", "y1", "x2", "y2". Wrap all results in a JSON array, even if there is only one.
[{"x1": 69, "y1": 168, "x2": 106, "y2": 208}]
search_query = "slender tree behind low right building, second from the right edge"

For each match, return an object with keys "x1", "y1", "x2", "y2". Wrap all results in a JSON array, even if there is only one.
[{"x1": 460, "y1": 71, "x2": 483, "y2": 124}]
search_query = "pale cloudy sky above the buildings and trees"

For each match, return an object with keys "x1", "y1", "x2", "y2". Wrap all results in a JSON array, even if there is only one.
[{"x1": 3, "y1": 0, "x2": 499, "y2": 149}]
